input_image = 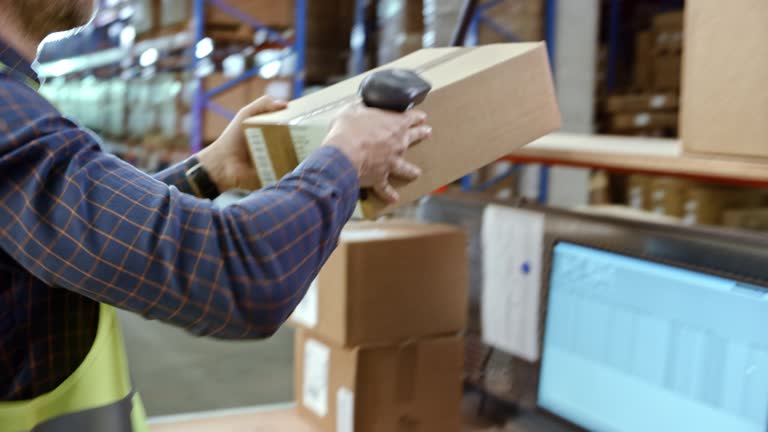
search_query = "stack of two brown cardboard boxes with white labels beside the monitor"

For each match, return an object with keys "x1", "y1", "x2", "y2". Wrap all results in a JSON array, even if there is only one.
[{"x1": 291, "y1": 221, "x2": 468, "y2": 432}]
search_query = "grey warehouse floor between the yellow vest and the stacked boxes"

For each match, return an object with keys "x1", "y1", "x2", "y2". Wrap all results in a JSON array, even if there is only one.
[{"x1": 120, "y1": 313, "x2": 293, "y2": 416}]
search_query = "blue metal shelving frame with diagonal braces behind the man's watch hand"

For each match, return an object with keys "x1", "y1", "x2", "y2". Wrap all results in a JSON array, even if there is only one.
[{"x1": 191, "y1": 0, "x2": 307, "y2": 153}]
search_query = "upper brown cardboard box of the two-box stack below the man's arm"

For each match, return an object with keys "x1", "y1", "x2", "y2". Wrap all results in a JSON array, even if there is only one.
[{"x1": 291, "y1": 221, "x2": 469, "y2": 346}]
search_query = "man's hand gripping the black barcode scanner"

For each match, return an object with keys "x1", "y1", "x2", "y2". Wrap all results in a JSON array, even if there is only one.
[{"x1": 325, "y1": 104, "x2": 432, "y2": 203}]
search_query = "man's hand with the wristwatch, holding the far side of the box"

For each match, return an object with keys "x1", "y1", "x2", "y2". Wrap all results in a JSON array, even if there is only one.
[{"x1": 197, "y1": 96, "x2": 288, "y2": 192}]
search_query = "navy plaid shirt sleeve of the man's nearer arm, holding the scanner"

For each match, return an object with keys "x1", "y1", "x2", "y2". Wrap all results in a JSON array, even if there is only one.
[{"x1": 0, "y1": 82, "x2": 358, "y2": 338}]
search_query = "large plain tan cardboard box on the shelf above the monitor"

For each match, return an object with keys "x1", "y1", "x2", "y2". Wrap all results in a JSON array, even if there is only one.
[{"x1": 682, "y1": 0, "x2": 768, "y2": 157}]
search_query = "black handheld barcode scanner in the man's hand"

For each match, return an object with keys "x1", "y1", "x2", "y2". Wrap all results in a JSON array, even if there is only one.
[{"x1": 359, "y1": 69, "x2": 432, "y2": 200}]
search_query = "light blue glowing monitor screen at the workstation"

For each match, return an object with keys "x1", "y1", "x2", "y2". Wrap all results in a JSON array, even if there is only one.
[{"x1": 538, "y1": 243, "x2": 768, "y2": 432}]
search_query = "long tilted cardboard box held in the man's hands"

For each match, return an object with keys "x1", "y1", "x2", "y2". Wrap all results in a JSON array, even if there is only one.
[{"x1": 244, "y1": 43, "x2": 560, "y2": 218}]
